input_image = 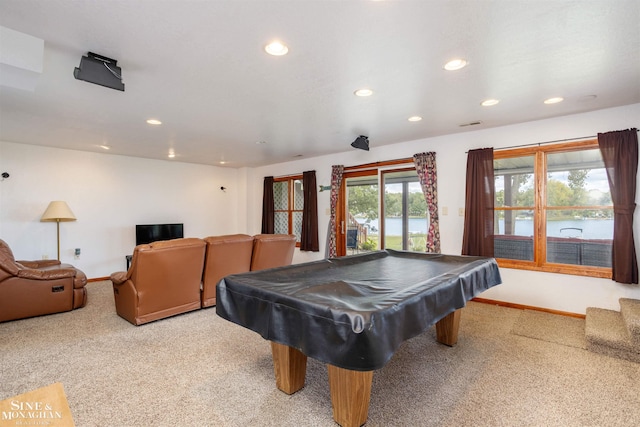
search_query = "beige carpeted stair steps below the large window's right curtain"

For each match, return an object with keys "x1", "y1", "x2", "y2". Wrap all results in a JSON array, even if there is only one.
[{"x1": 585, "y1": 298, "x2": 640, "y2": 363}]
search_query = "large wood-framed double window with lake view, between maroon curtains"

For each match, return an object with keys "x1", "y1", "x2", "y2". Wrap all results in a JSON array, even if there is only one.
[{"x1": 494, "y1": 140, "x2": 613, "y2": 277}]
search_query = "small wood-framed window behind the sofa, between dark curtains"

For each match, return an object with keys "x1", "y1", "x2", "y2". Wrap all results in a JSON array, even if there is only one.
[{"x1": 273, "y1": 175, "x2": 304, "y2": 246}]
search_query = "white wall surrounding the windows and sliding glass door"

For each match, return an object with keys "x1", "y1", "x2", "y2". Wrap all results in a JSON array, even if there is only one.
[{"x1": 247, "y1": 104, "x2": 640, "y2": 313}]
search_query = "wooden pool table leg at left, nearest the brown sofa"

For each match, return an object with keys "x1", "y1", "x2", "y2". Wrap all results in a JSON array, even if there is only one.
[{"x1": 271, "y1": 341, "x2": 307, "y2": 394}]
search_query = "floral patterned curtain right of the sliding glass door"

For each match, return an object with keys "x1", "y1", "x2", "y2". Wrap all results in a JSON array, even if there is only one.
[{"x1": 413, "y1": 152, "x2": 440, "y2": 254}]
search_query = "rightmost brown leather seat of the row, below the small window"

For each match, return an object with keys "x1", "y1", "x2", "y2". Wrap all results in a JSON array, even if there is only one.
[{"x1": 251, "y1": 234, "x2": 296, "y2": 271}]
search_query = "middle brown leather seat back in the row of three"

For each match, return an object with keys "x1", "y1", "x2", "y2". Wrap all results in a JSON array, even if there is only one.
[{"x1": 202, "y1": 234, "x2": 253, "y2": 308}]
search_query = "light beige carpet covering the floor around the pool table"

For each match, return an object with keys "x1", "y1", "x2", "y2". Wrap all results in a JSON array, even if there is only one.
[{"x1": 0, "y1": 282, "x2": 640, "y2": 427}]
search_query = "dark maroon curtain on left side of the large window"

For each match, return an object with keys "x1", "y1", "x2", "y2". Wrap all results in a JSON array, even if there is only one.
[{"x1": 462, "y1": 148, "x2": 496, "y2": 257}]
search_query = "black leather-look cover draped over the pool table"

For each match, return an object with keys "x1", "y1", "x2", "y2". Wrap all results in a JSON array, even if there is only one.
[{"x1": 216, "y1": 250, "x2": 501, "y2": 371}]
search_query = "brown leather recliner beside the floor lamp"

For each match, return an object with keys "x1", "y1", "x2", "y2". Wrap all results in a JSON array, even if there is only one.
[{"x1": 0, "y1": 239, "x2": 87, "y2": 322}]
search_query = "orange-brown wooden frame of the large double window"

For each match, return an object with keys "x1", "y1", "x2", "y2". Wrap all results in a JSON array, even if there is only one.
[{"x1": 493, "y1": 139, "x2": 612, "y2": 279}]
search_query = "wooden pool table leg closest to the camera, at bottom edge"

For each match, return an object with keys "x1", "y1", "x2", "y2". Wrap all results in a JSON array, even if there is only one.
[{"x1": 327, "y1": 365, "x2": 373, "y2": 427}]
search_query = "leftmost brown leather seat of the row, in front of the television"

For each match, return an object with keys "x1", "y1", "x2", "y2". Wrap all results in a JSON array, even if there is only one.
[{"x1": 110, "y1": 238, "x2": 205, "y2": 325}]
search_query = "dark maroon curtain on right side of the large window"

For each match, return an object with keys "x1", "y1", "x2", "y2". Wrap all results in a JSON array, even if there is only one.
[{"x1": 598, "y1": 128, "x2": 638, "y2": 283}]
